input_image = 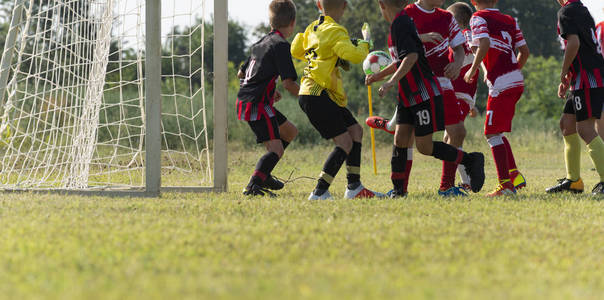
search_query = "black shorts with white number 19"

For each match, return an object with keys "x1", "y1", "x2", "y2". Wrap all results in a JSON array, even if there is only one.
[{"x1": 396, "y1": 96, "x2": 445, "y2": 136}]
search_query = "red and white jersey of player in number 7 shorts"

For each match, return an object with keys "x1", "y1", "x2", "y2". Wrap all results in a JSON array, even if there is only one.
[{"x1": 470, "y1": 8, "x2": 526, "y2": 97}]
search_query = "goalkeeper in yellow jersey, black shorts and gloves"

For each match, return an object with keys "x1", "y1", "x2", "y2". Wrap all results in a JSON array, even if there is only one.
[{"x1": 291, "y1": 0, "x2": 382, "y2": 200}]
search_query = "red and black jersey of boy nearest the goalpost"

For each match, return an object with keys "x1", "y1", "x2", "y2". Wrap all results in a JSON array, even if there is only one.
[{"x1": 236, "y1": 31, "x2": 298, "y2": 121}]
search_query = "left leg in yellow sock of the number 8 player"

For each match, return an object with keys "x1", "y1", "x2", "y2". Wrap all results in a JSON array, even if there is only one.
[{"x1": 545, "y1": 107, "x2": 584, "y2": 193}]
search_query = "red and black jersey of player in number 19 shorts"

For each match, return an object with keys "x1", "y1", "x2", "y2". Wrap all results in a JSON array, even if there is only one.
[{"x1": 388, "y1": 10, "x2": 442, "y2": 107}]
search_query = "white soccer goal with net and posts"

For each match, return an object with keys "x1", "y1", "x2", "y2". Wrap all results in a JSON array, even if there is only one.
[{"x1": 0, "y1": 0, "x2": 227, "y2": 195}]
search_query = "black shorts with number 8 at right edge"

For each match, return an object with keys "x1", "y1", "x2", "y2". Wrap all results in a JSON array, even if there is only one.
[{"x1": 564, "y1": 88, "x2": 604, "y2": 122}]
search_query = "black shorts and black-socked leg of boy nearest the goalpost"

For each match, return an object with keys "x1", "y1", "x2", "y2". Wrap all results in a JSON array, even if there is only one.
[{"x1": 243, "y1": 115, "x2": 283, "y2": 196}]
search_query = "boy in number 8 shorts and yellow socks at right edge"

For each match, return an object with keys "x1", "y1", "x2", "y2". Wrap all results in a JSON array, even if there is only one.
[{"x1": 547, "y1": 0, "x2": 604, "y2": 195}]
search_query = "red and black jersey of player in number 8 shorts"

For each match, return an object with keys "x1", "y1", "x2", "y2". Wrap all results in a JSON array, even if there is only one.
[{"x1": 558, "y1": 0, "x2": 604, "y2": 90}]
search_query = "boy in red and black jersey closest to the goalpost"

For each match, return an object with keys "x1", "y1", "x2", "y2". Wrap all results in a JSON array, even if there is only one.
[{"x1": 236, "y1": 0, "x2": 299, "y2": 196}]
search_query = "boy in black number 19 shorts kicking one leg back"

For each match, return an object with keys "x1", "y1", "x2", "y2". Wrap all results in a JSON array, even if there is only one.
[{"x1": 379, "y1": 0, "x2": 484, "y2": 198}]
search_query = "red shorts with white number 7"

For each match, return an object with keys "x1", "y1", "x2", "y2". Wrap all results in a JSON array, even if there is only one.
[{"x1": 484, "y1": 87, "x2": 524, "y2": 135}]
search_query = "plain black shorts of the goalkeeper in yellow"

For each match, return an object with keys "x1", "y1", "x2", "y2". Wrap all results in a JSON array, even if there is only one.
[{"x1": 298, "y1": 91, "x2": 359, "y2": 140}]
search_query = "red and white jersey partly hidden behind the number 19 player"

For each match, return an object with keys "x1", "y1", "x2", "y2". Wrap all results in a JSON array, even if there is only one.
[{"x1": 405, "y1": 4, "x2": 465, "y2": 77}]
